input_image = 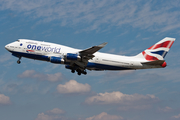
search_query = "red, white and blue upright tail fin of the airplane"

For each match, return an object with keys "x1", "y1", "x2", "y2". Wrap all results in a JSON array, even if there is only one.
[{"x1": 136, "y1": 37, "x2": 175, "y2": 61}]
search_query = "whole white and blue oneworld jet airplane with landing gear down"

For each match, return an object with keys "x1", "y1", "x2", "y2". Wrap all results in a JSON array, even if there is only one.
[{"x1": 5, "y1": 37, "x2": 175, "y2": 75}]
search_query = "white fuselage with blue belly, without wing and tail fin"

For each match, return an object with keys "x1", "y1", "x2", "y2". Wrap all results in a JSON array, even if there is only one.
[{"x1": 5, "y1": 39, "x2": 165, "y2": 73}]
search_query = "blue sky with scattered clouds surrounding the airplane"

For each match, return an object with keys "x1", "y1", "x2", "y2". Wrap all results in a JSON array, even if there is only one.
[{"x1": 0, "y1": 0, "x2": 180, "y2": 120}]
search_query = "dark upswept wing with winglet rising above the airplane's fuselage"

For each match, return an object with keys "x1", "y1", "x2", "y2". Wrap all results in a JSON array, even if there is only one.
[{"x1": 79, "y1": 42, "x2": 107, "y2": 60}]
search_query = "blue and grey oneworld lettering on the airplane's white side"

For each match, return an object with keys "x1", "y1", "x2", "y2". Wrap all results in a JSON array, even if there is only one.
[{"x1": 27, "y1": 44, "x2": 61, "y2": 53}]
